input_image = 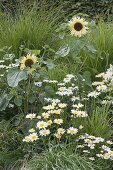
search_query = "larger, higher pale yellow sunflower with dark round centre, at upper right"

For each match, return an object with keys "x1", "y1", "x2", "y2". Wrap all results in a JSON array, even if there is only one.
[{"x1": 68, "y1": 17, "x2": 88, "y2": 37}]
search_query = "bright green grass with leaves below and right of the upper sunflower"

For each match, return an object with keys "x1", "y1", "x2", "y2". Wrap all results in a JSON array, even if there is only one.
[{"x1": 49, "y1": 21, "x2": 113, "y2": 80}]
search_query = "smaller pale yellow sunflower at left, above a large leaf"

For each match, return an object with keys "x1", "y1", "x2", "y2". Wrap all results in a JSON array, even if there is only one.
[{"x1": 20, "y1": 54, "x2": 37, "y2": 70}]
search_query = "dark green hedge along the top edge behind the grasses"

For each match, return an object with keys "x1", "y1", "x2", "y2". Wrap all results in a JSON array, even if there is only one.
[{"x1": 1, "y1": 0, "x2": 113, "y2": 20}]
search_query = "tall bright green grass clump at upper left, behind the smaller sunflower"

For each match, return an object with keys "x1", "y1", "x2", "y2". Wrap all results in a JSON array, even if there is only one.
[{"x1": 0, "y1": 3, "x2": 62, "y2": 56}]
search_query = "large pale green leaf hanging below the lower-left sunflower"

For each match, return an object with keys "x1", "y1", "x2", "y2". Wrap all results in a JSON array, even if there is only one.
[{"x1": 7, "y1": 68, "x2": 27, "y2": 87}]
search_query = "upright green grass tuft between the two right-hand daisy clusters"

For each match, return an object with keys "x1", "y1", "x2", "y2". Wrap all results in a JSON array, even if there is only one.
[{"x1": 83, "y1": 104, "x2": 113, "y2": 139}]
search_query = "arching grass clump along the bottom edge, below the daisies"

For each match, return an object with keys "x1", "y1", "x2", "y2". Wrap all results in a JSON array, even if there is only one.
[{"x1": 27, "y1": 145, "x2": 111, "y2": 170}]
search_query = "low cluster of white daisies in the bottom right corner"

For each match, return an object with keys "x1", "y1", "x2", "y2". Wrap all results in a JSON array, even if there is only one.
[{"x1": 77, "y1": 133, "x2": 113, "y2": 160}]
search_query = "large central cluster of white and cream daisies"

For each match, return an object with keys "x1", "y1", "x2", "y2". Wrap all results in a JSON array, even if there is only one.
[{"x1": 23, "y1": 74, "x2": 88, "y2": 142}]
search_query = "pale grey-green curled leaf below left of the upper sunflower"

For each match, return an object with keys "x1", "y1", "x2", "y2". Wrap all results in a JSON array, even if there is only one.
[{"x1": 55, "y1": 44, "x2": 70, "y2": 58}]
